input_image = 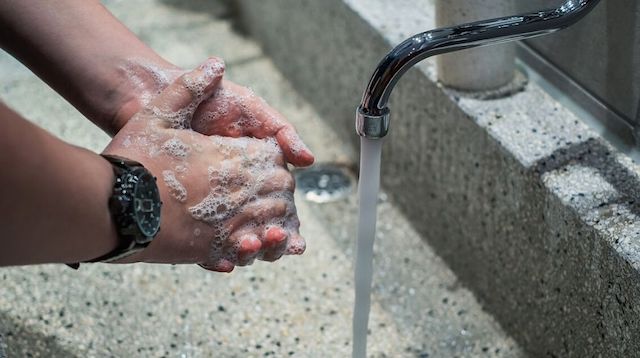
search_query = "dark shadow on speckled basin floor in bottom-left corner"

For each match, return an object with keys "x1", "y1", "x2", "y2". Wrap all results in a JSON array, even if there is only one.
[{"x1": 0, "y1": 312, "x2": 79, "y2": 358}]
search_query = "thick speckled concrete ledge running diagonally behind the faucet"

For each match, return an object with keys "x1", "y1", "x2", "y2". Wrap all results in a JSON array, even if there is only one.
[{"x1": 239, "y1": 0, "x2": 640, "y2": 357}]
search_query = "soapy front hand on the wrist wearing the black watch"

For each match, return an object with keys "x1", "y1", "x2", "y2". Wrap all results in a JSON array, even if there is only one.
[{"x1": 105, "y1": 59, "x2": 310, "y2": 272}]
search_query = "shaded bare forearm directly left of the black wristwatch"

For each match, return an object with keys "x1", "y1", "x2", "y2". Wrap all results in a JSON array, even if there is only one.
[{"x1": 0, "y1": 103, "x2": 118, "y2": 266}]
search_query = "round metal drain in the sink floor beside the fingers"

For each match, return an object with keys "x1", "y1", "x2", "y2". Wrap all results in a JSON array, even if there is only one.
[{"x1": 294, "y1": 164, "x2": 355, "y2": 203}]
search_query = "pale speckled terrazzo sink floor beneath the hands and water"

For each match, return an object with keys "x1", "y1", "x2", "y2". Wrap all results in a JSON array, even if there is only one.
[{"x1": 0, "y1": 0, "x2": 522, "y2": 357}]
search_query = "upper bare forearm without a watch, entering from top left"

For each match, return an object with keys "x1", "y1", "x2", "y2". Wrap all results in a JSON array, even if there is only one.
[{"x1": 0, "y1": 0, "x2": 174, "y2": 134}]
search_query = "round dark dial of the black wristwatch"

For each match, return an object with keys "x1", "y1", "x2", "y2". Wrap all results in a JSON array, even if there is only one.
[{"x1": 133, "y1": 171, "x2": 162, "y2": 241}]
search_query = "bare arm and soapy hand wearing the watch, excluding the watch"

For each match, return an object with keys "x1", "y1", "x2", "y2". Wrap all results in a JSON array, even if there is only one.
[{"x1": 0, "y1": 63, "x2": 305, "y2": 271}]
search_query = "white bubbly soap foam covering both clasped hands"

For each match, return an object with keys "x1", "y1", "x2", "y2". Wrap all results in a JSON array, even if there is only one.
[{"x1": 125, "y1": 61, "x2": 304, "y2": 267}]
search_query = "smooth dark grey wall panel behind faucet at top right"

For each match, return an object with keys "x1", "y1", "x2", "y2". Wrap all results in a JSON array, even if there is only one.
[{"x1": 516, "y1": 0, "x2": 640, "y2": 125}]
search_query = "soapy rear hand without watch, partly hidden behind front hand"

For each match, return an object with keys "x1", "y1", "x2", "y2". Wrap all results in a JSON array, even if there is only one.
[{"x1": 114, "y1": 61, "x2": 314, "y2": 166}]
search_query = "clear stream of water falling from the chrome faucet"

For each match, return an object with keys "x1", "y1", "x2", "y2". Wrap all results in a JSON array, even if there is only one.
[{"x1": 353, "y1": 137, "x2": 382, "y2": 358}]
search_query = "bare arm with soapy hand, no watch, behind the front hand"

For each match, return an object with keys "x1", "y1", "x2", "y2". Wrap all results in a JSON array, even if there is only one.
[{"x1": 0, "y1": 0, "x2": 314, "y2": 166}]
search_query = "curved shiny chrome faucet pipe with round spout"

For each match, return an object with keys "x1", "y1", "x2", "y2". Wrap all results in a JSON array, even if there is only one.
[{"x1": 356, "y1": 0, "x2": 600, "y2": 139}]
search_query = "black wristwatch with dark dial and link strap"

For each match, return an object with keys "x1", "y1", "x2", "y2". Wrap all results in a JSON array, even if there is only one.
[{"x1": 67, "y1": 154, "x2": 162, "y2": 269}]
